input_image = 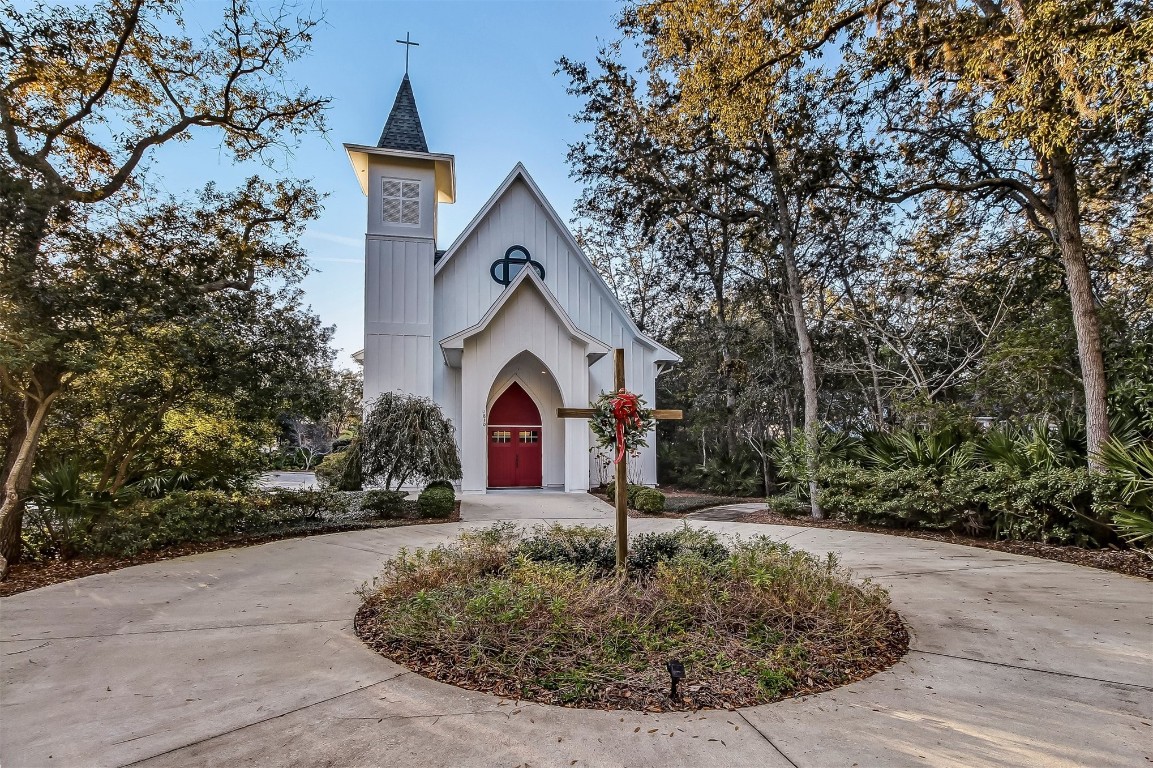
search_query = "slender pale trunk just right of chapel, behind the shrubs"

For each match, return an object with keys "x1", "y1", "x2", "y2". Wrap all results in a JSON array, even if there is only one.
[{"x1": 766, "y1": 138, "x2": 824, "y2": 520}]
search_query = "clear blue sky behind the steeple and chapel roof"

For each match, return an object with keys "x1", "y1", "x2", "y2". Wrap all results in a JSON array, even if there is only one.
[{"x1": 153, "y1": 0, "x2": 619, "y2": 367}]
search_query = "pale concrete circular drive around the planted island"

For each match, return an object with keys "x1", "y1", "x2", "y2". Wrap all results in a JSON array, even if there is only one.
[{"x1": 0, "y1": 494, "x2": 1153, "y2": 768}]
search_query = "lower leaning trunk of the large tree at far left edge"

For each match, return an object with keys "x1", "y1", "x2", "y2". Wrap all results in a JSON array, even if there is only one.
[{"x1": 0, "y1": 366, "x2": 63, "y2": 581}]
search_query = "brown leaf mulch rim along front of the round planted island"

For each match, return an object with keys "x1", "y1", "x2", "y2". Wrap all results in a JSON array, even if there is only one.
[{"x1": 353, "y1": 604, "x2": 909, "y2": 713}]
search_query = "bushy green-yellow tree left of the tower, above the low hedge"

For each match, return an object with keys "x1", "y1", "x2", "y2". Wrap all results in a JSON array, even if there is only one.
[{"x1": 42, "y1": 281, "x2": 334, "y2": 492}]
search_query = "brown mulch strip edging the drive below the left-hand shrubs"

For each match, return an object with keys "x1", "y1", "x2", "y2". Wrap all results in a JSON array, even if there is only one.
[{"x1": 0, "y1": 503, "x2": 460, "y2": 597}]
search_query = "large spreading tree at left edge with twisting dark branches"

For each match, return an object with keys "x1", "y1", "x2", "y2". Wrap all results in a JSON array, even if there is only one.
[{"x1": 0, "y1": 0, "x2": 326, "y2": 578}]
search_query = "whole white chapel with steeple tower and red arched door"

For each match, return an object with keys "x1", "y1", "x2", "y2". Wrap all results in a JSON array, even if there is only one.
[{"x1": 345, "y1": 75, "x2": 680, "y2": 492}]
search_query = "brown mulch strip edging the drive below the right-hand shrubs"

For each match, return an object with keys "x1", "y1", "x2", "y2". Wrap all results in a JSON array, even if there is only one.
[{"x1": 738, "y1": 510, "x2": 1153, "y2": 580}]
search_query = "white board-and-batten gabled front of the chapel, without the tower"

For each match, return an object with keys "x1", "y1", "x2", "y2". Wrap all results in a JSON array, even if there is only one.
[{"x1": 432, "y1": 166, "x2": 671, "y2": 490}]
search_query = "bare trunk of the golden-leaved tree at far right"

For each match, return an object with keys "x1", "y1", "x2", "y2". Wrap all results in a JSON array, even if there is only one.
[{"x1": 1049, "y1": 152, "x2": 1109, "y2": 461}]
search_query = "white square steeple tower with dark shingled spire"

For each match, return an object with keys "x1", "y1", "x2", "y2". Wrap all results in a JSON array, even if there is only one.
[{"x1": 345, "y1": 74, "x2": 457, "y2": 402}]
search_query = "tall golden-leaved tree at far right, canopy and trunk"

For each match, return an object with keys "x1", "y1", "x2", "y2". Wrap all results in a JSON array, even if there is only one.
[{"x1": 632, "y1": 0, "x2": 1153, "y2": 466}]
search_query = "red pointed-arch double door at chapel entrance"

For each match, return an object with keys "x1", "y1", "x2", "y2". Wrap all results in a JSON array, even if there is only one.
[{"x1": 489, "y1": 382, "x2": 543, "y2": 488}]
